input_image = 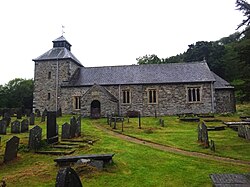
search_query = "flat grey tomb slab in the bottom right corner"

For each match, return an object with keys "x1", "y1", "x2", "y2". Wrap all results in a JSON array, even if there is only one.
[{"x1": 210, "y1": 173, "x2": 250, "y2": 187}]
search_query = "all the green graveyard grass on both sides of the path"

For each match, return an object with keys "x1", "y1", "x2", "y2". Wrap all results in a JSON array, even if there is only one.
[{"x1": 0, "y1": 104, "x2": 250, "y2": 187}]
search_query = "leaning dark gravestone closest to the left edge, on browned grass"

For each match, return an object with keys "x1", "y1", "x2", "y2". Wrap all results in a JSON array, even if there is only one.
[{"x1": 4, "y1": 136, "x2": 20, "y2": 162}]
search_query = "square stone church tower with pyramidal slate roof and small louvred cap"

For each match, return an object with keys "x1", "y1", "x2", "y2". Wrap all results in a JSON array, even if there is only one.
[{"x1": 33, "y1": 36, "x2": 83, "y2": 111}]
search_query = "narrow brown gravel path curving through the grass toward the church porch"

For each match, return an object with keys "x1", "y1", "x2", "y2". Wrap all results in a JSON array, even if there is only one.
[{"x1": 96, "y1": 125, "x2": 250, "y2": 166}]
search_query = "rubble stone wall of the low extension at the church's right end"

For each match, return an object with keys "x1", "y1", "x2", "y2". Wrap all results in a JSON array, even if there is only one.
[{"x1": 215, "y1": 89, "x2": 236, "y2": 113}]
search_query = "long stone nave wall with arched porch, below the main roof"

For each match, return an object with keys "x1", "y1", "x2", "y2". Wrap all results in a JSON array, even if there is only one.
[{"x1": 60, "y1": 83, "x2": 213, "y2": 116}]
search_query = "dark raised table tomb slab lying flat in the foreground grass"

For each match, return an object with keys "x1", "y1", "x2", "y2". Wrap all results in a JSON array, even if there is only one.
[{"x1": 54, "y1": 153, "x2": 115, "y2": 166}]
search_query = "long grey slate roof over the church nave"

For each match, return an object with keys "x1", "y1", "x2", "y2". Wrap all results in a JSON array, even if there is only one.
[{"x1": 64, "y1": 62, "x2": 215, "y2": 86}]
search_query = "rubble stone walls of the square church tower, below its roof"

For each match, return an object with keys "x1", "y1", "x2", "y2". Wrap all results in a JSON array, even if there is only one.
[{"x1": 33, "y1": 60, "x2": 78, "y2": 111}]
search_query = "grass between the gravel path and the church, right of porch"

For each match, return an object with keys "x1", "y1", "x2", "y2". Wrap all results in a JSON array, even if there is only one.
[{"x1": 94, "y1": 109, "x2": 250, "y2": 161}]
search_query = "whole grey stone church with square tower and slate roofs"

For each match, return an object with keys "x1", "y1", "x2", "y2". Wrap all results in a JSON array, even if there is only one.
[{"x1": 33, "y1": 36, "x2": 235, "y2": 117}]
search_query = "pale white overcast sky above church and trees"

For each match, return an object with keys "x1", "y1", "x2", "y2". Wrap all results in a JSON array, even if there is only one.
[{"x1": 0, "y1": 0, "x2": 244, "y2": 85}]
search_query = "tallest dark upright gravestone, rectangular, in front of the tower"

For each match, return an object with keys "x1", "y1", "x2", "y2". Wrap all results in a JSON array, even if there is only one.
[{"x1": 47, "y1": 111, "x2": 58, "y2": 144}]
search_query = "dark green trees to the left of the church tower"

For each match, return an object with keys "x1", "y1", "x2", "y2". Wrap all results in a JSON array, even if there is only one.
[{"x1": 0, "y1": 78, "x2": 34, "y2": 108}]
